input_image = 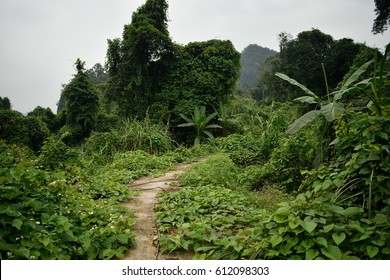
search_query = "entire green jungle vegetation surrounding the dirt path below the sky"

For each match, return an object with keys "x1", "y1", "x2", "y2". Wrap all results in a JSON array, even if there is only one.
[{"x1": 0, "y1": 0, "x2": 390, "y2": 260}]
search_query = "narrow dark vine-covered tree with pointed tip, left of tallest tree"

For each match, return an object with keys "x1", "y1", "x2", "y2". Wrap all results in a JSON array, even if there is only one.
[{"x1": 62, "y1": 59, "x2": 99, "y2": 142}]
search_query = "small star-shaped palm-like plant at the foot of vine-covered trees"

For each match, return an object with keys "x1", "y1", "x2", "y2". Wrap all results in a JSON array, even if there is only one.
[{"x1": 178, "y1": 106, "x2": 222, "y2": 145}]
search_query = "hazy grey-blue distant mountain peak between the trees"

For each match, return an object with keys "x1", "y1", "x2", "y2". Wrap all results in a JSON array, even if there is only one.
[{"x1": 238, "y1": 44, "x2": 277, "y2": 89}]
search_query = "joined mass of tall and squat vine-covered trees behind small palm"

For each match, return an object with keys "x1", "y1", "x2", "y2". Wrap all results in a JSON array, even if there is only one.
[{"x1": 106, "y1": 0, "x2": 240, "y2": 124}]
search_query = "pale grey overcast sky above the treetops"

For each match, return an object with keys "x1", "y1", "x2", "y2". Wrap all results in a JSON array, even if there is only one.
[{"x1": 0, "y1": 0, "x2": 390, "y2": 113}]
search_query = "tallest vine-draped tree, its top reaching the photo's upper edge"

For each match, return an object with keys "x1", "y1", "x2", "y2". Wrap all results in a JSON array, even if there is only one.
[{"x1": 107, "y1": 0, "x2": 174, "y2": 117}]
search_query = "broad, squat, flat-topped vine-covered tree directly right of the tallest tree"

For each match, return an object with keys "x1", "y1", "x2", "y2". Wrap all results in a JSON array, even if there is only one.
[{"x1": 155, "y1": 40, "x2": 240, "y2": 125}]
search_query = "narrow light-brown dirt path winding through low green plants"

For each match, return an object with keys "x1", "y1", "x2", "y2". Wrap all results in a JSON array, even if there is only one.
[{"x1": 123, "y1": 164, "x2": 192, "y2": 260}]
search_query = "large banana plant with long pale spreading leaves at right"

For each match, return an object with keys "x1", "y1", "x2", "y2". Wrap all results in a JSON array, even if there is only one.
[{"x1": 275, "y1": 60, "x2": 374, "y2": 134}]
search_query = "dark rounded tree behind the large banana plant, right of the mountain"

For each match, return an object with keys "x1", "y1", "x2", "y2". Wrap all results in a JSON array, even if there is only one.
[{"x1": 253, "y1": 29, "x2": 366, "y2": 101}]
